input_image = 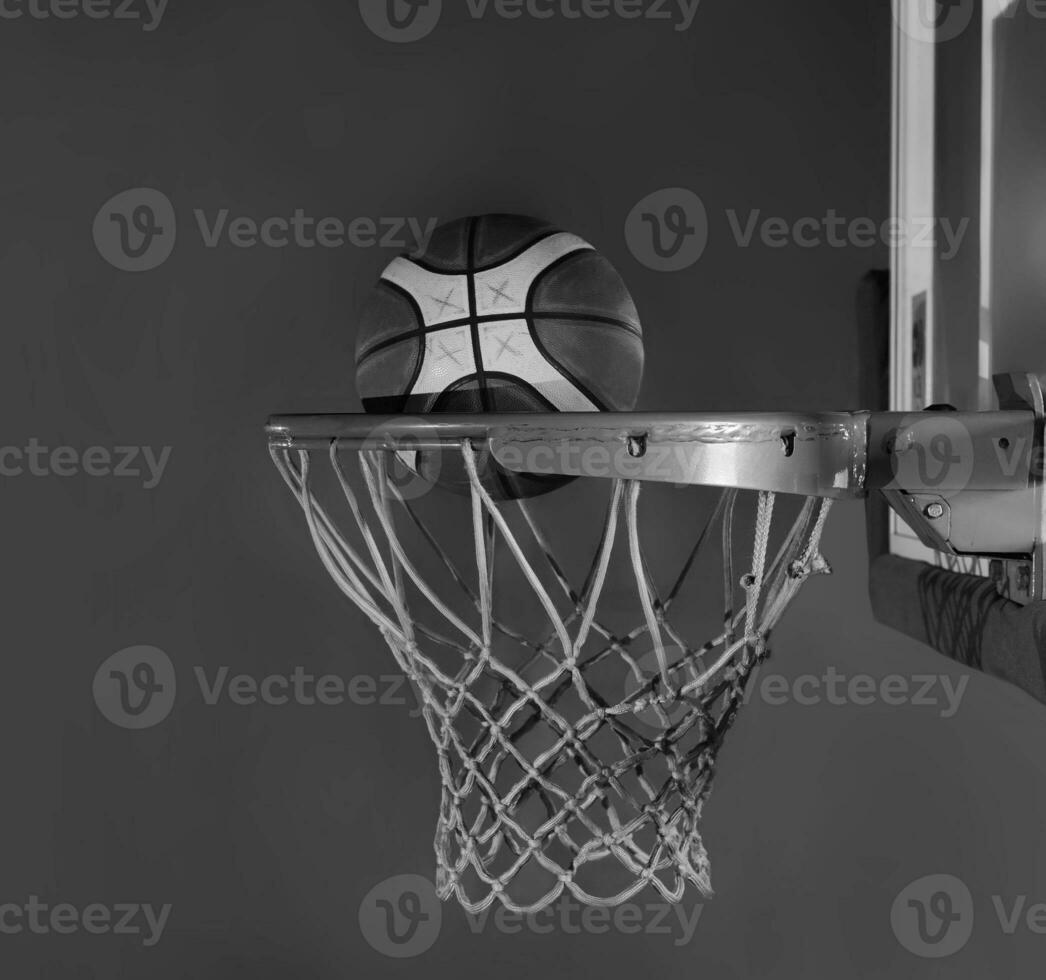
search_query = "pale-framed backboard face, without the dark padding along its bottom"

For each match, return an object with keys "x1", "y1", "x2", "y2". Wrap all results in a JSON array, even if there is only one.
[{"x1": 890, "y1": 0, "x2": 1046, "y2": 575}]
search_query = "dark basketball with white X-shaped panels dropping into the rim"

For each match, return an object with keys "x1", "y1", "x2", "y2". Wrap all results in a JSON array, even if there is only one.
[{"x1": 356, "y1": 214, "x2": 643, "y2": 500}]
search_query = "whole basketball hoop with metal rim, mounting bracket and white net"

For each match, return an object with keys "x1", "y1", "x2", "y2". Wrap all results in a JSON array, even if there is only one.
[{"x1": 268, "y1": 389, "x2": 1046, "y2": 913}]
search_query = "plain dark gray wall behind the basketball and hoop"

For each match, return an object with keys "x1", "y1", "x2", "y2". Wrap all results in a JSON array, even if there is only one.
[{"x1": 0, "y1": 0, "x2": 1046, "y2": 980}]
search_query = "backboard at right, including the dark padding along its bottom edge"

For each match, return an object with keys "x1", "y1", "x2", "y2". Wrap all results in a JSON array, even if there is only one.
[{"x1": 870, "y1": 0, "x2": 1046, "y2": 701}]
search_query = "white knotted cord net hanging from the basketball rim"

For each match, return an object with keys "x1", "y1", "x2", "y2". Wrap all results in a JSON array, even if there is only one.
[{"x1": 273, "y1": 441, "x2": 829, "y2": 912}]
